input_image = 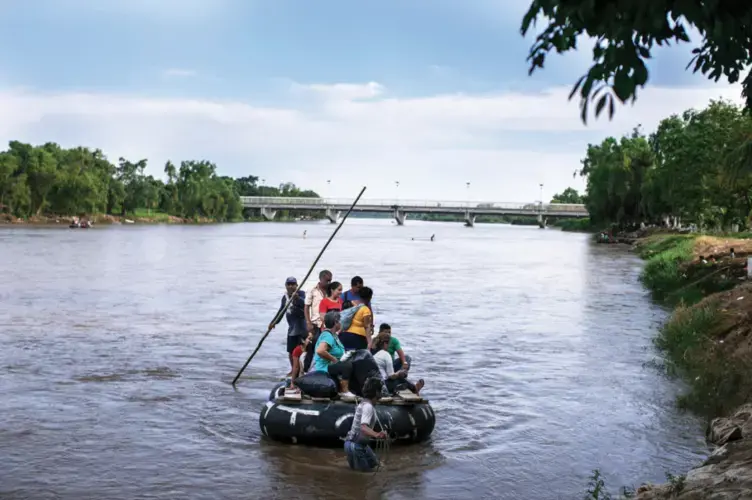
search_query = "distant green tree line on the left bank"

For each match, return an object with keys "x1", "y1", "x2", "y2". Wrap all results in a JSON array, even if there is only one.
[{"x1": 0, "y1": 141, "x2": 318, "y2": 221}]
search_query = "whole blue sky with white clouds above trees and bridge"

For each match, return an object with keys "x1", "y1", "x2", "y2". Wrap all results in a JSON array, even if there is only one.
[{"x1": 0, "y1": 0, "x2": 741, "y2": 202}]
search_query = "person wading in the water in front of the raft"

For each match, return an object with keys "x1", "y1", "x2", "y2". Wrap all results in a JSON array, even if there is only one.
[{"x1": 345, "y1": 378, "x2": 387, "y2": 472}]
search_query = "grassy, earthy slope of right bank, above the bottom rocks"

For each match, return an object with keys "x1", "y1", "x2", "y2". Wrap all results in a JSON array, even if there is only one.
[{"x1": 636, "y1": 234, "x2": 752, "y2": 418}]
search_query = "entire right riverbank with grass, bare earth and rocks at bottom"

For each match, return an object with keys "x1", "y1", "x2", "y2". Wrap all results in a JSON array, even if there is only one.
[{"x1": 608, "y1": 234, "x2": 752, "y2": 500}]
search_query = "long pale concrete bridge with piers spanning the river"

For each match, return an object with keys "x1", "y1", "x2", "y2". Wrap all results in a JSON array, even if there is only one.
[{"x1": 240, "y1": 196, "x2": 588, "y2": 227}]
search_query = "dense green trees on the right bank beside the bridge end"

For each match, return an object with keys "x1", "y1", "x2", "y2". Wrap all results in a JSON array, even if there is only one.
[{"x1": 579, "y1": 101, "x2": 752, "y2": 230}]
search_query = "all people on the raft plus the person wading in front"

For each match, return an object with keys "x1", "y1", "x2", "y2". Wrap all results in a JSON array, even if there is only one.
[{"x1": 269, "y1": 270, "x2": 424, "y2": 472}]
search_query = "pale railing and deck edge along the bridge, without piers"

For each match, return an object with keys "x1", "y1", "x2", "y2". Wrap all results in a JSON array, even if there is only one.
[{"x1": 240, "y1": 196, "x2": 587, "y2": 213}]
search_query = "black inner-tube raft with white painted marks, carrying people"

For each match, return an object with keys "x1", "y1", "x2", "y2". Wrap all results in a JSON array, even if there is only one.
[{"x1": 259, "y1": 382, "x2": 436, "y2": 446}]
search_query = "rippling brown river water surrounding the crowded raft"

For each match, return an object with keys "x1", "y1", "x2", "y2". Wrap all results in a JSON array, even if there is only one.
[{"x1": 0, "y1": 219, "x2": 707, "y2": 500}]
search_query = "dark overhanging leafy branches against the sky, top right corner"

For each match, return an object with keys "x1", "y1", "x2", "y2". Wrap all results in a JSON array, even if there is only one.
[{"x1": 521, "y1": 0, "x2": 752, "y2": 122}]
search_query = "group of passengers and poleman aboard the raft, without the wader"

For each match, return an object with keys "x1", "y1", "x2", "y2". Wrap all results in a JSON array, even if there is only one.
[{"x1": 269, "y1": 270, "x2": 424, "y2": 399}]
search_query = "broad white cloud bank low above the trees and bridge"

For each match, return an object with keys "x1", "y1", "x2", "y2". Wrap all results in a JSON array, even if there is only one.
[{"x1": 0, "y1": 82, "x2": 740, "y2": 201}]
